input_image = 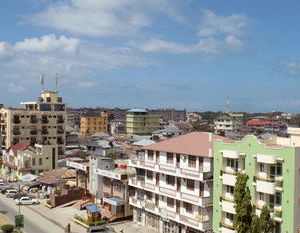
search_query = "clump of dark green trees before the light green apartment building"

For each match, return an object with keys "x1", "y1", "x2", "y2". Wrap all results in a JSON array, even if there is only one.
[{"x1": 233, "y1": 173, "x2": 274, "y2": 233}]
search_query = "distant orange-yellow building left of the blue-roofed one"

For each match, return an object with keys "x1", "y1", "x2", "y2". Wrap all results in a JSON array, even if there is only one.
[{"x1": 80, "y1": 112, "x2": 108, "y2": 134}]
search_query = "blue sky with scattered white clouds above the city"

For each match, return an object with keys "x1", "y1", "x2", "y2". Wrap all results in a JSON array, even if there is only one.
[{"x1": 0, "y1": 0, "x2": 300, "y2": 112}]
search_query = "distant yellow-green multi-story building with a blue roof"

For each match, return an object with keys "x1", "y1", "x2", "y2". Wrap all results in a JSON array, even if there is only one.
[{"x1": 126, "y1": 109, "x2": 160, "y2": 135}]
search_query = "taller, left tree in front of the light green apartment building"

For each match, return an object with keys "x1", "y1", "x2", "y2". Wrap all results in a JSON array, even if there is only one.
[{"x1": 233, "y1": 173, "x2": 253, "y2": 233}]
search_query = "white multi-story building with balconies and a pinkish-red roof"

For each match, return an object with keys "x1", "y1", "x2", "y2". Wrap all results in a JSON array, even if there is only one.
[{"x1": 129, "y1": 132, "x2": 229, "y2": 233}]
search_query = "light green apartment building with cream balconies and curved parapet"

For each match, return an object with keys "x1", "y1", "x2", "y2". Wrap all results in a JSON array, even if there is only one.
[{"x1": 213, "y1": 135, "x2": 300, "y2": 233}]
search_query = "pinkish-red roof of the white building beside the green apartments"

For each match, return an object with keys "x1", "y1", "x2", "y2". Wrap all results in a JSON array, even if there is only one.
[{"x1": 144, "y1": 132, "x2": 234, "y2": 157}]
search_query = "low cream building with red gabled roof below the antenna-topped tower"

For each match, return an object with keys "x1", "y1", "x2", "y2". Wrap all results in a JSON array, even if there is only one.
[{"x1": 2, "y1": 142, "x2": 58, "y2": 180}]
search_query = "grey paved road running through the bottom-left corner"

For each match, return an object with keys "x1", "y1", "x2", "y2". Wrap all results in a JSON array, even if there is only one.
[{"x1": 0, "y1": 194, "x2": 64, "y2": 233}]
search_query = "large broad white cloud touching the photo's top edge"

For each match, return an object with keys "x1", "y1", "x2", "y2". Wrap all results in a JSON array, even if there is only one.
[{"x1": 27, "y1": 0, "x2": 183, "y2": 36}]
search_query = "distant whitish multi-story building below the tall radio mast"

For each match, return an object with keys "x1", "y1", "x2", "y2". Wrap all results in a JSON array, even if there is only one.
[{"x1": 214, "y1": 113, "x2": 243, "y2": 133}]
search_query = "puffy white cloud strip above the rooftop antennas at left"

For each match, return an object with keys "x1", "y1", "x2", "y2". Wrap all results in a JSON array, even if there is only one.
[{"x1": 14, "y1": 34, "x2": 80, "y2": 53}]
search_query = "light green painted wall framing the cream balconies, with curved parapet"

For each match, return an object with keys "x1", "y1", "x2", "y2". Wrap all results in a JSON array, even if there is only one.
[{"x1": 213, "y1": 135, "x2": 299, "y2": 233}]
